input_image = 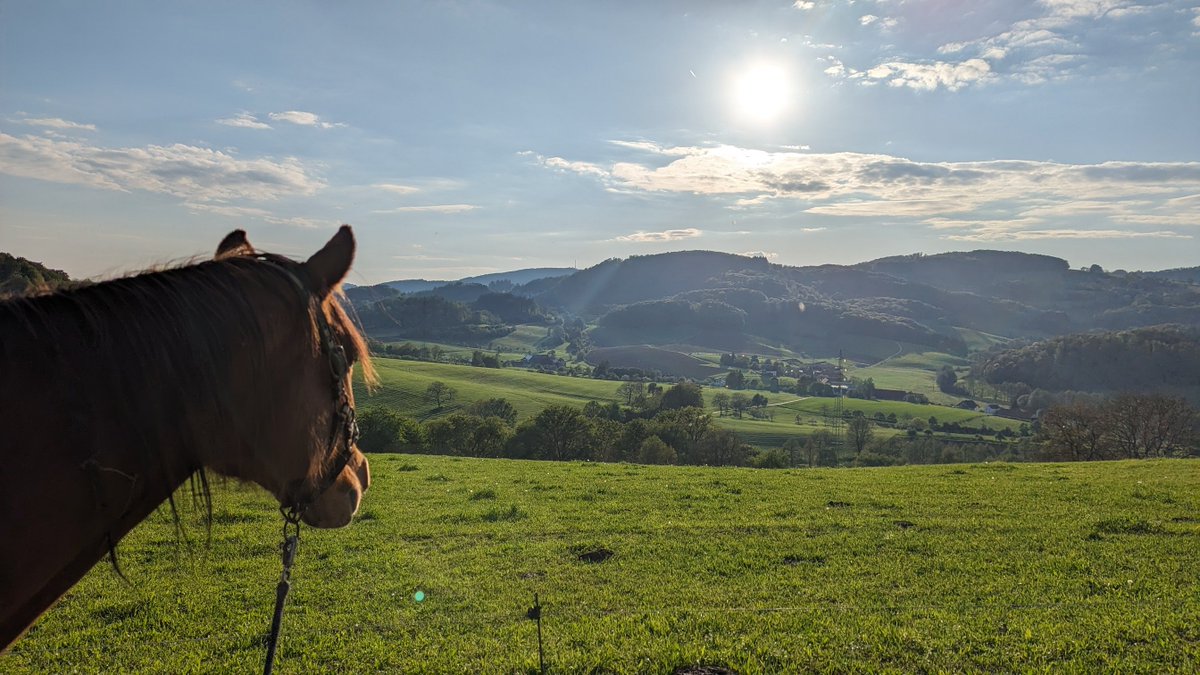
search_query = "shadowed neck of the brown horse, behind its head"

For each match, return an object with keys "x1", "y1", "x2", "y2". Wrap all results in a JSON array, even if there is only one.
[{"x1": 0, "y1": 273, "x2": 258, "y2": 646}]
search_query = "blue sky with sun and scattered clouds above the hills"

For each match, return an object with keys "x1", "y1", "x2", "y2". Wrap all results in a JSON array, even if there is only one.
[{"x1": 0, "y1": 0, "x2": 1200, "y2": 285}]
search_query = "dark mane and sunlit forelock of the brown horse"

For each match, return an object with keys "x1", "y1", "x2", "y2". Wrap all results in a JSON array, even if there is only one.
[{"x1": 0, "y1": 253, "x2": 378, "y2": 538}]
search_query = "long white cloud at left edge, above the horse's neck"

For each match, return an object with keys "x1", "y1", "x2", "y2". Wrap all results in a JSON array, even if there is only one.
[{"x1": 0, "y1": 133, "x2": 325, "y2": 203}]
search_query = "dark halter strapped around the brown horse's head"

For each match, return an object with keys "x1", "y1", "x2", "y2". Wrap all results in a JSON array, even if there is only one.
[{"x1": 254, "y1": 253, "x2": 359, "y2": 524}]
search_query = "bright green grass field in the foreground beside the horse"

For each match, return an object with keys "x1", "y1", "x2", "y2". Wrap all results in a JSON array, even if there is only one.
[{"x1": 9, "y1": 455, "x2": 1200, "y2": 674}]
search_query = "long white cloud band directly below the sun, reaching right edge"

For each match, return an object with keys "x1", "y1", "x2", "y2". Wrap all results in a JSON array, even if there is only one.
[{"x1": 545, "y1": 139, "x2": 1200, "y2": 241}]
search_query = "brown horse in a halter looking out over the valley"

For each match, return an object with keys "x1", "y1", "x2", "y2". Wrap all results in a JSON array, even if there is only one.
[{"x1": 0, "y1": 226, "x2": 374, "y2": 649}]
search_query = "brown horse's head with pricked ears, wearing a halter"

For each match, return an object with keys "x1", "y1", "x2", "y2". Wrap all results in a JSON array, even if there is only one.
[{"x1": 204, "y1": 226, "x2": 373, "y2": 527}]
